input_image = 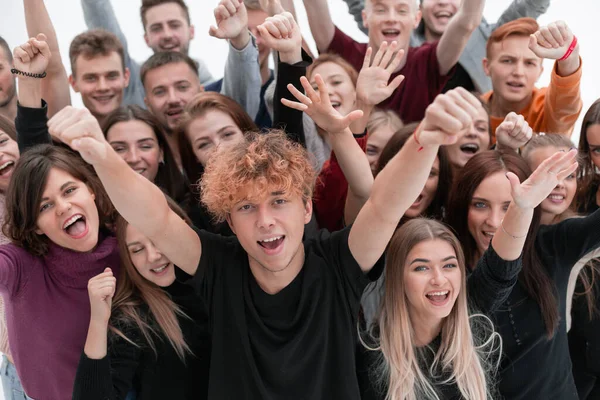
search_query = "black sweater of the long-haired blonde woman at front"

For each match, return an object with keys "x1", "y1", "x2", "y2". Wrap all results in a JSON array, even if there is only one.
[{"x1": 357, "y1": 245, "x2": 522, "y2": 400}]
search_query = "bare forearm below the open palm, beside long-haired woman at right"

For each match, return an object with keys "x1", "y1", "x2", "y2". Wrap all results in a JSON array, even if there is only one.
[{"x1": 492, "y1": 202, "x2": 533, "y2": 261}]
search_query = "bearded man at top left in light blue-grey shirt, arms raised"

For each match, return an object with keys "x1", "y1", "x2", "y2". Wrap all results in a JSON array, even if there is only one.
[{"x1": 81, "y1": 0, "x2": 261, "y2": 118}]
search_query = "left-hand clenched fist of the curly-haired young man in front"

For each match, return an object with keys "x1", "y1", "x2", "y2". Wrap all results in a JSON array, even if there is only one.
[{"x1": 48, "y1": 106, "x2": 110, "y2": 165}]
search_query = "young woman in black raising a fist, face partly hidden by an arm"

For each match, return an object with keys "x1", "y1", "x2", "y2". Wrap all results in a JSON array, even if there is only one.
[{"x1": 73, "y1": 198, "x2": 210, "y2": 400}]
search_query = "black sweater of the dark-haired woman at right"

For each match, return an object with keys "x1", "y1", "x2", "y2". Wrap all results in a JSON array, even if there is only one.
[{"x1": 494, "y1": 211, "x2": 600, "y2": 400}]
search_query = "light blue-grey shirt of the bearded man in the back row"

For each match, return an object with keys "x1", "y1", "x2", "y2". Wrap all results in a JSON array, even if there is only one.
[{"x1": 81, "y1": 0, "x2": 262, "y2": 118}]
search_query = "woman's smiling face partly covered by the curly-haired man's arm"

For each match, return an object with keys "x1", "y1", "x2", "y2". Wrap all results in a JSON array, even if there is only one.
[{"x1": 125, "y1": 225, "x2": 175, "y2": 287}]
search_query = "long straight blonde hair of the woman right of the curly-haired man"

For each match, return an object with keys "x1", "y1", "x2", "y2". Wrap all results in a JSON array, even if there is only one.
[{"x1": 371, "y1": 218, "x2": 501, "y2": 400}]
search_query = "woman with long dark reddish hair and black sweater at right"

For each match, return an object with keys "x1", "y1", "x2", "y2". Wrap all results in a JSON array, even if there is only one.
[{"x1": 448, "y1": 150, "x2": 600, "y2": 399}]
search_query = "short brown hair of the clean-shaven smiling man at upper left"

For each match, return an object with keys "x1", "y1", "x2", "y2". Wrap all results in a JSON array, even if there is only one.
[{"x1": 69, "y1": 29, "x2": 125, "y2": 76}]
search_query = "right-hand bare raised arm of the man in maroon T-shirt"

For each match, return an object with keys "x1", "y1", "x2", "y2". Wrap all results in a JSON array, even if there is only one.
[{"x1": 436, "y1": 0, "x2": 485, "y2": 75}]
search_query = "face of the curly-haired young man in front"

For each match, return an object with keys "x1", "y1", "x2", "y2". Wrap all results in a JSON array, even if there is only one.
[{"x1": 228, "y1": 190, "x2": 312, "y2": 274}]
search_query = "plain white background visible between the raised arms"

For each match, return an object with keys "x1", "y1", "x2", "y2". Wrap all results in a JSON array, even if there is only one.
[{"x1": 0, "y1": 0, "x2": 600, "y2": 399}]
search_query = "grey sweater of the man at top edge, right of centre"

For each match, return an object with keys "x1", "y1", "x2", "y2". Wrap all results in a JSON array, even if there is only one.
[{"x1": 344, "y1": 0, "x2": 550, "y2": 93}]
